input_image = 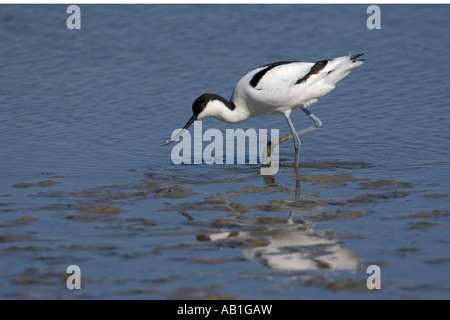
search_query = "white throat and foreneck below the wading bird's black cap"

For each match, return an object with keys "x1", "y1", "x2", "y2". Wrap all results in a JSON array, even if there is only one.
[{"x1": 198, "y1": 99, "x2": 249, "y2": 123}]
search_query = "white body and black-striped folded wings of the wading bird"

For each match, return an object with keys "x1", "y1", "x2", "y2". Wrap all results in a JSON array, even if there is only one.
[{"x1": 231, "y1": 54, "x2": 363, "y2": 116}]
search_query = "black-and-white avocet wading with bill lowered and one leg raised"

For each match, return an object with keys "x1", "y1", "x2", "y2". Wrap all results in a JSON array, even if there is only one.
[{"x1": 163, "y1": 53, "x2": 364, "y2": 169}]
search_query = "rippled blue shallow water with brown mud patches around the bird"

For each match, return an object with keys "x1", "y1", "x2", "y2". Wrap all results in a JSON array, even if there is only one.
[{"x1": 0, "y1": 5, "x2": 450, "y2": 299}]
